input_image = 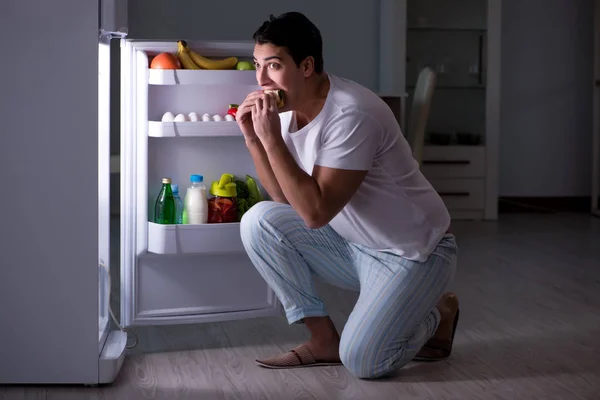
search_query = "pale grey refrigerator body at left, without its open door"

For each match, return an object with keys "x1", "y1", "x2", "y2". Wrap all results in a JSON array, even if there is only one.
[{"x1": 0, "y1": 0, "x2": 126, "y2": 384}]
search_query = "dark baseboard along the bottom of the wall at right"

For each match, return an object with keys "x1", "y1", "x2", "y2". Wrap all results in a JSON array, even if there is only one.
[{"x1": 498, "y1": 196, "x2": 592, "y2": 214}]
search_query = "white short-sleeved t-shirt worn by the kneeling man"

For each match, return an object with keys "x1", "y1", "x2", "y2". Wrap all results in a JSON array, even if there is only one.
[{"x1": 280, "y1": 74, "x2": 450, "y2": 261}]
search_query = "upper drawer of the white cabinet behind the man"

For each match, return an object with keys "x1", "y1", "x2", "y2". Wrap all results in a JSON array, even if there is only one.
[{"x1": 421, "y1": 146, "x2": 485, "y2": 179}]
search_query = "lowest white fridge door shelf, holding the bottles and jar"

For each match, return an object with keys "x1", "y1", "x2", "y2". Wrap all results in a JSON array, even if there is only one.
[{"x1": 148, "y1": 222, "x2": 245, "y2": 254}]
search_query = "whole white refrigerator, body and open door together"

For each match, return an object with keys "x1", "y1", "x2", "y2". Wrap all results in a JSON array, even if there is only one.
[{"x1": 0, "y1": 0, "x2": 280, "y2": 385}]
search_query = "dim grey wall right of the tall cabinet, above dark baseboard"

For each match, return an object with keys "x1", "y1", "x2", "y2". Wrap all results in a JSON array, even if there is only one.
[{"x1": 500, "y1": 0, "x2": 593, "y2": 197}]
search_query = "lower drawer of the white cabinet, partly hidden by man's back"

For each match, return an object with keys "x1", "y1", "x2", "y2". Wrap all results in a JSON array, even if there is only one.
[{"x1": 430, "y1": 179, "x2": 485, "y2": 210}]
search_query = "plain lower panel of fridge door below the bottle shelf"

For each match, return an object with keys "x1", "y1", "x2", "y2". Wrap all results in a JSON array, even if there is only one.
[{"x1": 135, "y1": 253, "x2": 277, "y2": 323}]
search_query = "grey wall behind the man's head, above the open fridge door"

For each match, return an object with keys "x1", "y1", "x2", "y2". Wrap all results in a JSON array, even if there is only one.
[{"x1": 128, "y1": 0, "x2": 379, "y2": 90}]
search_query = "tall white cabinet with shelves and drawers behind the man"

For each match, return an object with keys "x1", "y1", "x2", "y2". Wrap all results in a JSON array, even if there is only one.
[{"x1": 380, "y1": 0, "x2": 502, "y2": 219}]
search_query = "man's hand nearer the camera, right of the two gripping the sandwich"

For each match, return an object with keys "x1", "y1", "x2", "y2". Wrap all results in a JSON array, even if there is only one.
[{"x1": 252, "y1": 92, "x2": 282, "y2": 148}]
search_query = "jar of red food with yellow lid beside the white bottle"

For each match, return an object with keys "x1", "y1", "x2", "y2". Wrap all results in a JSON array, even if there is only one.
[{"x1": 208, "y1": 174, "x2": 238, "y2": 224}]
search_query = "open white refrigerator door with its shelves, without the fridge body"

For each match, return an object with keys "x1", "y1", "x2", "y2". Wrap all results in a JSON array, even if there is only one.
[{"x1": 121, "y1": 39, "x2": 279, "y2": 332}]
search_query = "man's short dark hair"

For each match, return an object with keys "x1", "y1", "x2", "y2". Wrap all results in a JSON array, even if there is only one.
[{"x1": 252, "y1": 12, "x2": 323, "y2": 74}]
